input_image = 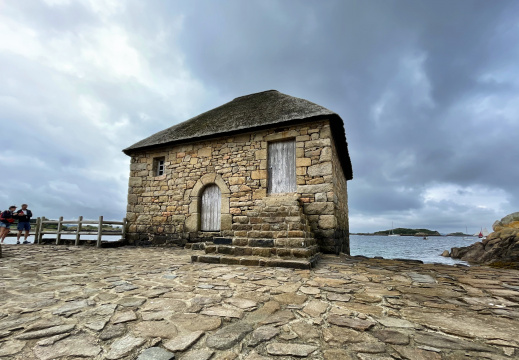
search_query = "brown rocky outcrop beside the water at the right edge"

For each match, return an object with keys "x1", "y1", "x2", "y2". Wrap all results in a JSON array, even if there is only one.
[{"x1": 450, "y1": 212, "x2": 519, "y2": 267}]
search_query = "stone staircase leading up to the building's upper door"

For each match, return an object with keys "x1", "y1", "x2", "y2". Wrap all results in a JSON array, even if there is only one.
[{"x1": 191, "y1": 194, "x2": 320, "y2": 269}]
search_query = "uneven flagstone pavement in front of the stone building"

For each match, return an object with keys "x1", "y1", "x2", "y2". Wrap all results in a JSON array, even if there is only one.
[{"x1": 0, "y1": 245, "x2": 519, "y2": 360}]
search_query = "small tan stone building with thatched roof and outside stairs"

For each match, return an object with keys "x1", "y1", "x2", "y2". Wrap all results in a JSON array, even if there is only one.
[{"x1": 123, "y1": 90, "x2": 352, "y2": 262}]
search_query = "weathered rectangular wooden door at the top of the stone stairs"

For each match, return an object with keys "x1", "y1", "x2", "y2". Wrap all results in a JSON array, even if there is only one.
[{"x1": 268, "y1": 140, "x2": 296, "y2": 193}]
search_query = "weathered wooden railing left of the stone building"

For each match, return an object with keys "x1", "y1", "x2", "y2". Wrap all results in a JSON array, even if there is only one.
[{"x1": 34, "y1": 216, "x2": 126, "y2": 247}]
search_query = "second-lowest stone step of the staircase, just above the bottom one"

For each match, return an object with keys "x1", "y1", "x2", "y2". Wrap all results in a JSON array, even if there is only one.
[{"x1": 204, "y1": 244, "x2": 319, "y2": 259}]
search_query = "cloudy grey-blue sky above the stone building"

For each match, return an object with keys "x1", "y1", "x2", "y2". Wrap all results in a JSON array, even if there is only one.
[{"x1": 0, "y1": 0, "x2": 519, "y2": 233}]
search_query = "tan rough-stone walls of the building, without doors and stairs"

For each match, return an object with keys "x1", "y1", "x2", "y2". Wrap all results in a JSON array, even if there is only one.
[{"x1": 127, "y1": 120, "x2": 349, "y2": 252}]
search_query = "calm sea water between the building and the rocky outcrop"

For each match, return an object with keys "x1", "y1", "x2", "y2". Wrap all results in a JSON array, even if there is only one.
[{"x1": 350, "y1": 235, "x2": 479, "y2": 264}]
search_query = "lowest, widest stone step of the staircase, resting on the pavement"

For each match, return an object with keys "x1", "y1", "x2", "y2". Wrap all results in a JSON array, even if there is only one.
[{"x1": 191, "y1": 254, "x2": 320, "y2": 269}]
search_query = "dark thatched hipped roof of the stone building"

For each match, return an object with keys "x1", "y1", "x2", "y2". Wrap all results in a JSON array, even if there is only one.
[{"x1": 123, "y1": 90, "x2": 352, "y2": 179}]
